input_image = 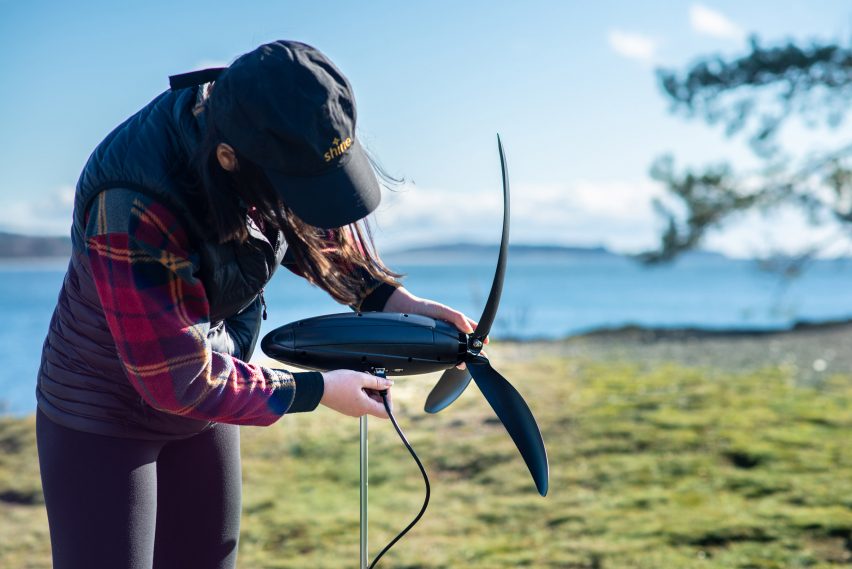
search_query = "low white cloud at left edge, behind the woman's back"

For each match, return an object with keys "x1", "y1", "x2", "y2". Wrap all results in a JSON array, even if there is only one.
[{"x1": 0, "y1": 186, "x2": 74, "y2": 235}]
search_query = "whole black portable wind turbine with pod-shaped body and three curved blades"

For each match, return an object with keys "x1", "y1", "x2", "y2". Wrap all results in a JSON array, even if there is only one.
[{"x1": 261, "y1": 136, "x2": 549, "y2": 496}]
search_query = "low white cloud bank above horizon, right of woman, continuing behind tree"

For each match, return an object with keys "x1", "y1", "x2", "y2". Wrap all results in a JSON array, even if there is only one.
[{"x1": 375, "y1": 179, "x2": 852, "y2": 258}]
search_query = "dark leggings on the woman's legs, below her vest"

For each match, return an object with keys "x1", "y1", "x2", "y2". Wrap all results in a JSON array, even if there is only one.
[{"x1": 36, "y1": 412, "x2": 242, "y2": 569}]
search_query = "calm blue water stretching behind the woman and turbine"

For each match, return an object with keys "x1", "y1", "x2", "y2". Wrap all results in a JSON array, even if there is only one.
[{"x1": 0, "y1": 255, "x2": 852, "y2": 413}]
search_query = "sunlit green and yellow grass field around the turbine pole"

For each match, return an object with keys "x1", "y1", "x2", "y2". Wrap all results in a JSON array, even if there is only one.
[{"x1": 0, "y1": 332, "x2": 852, "y2": 569}]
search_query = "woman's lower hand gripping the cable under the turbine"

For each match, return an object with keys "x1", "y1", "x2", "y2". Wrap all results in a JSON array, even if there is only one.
[{"x1": 320, "y1": 369, "x2": 393, "y2": 419}]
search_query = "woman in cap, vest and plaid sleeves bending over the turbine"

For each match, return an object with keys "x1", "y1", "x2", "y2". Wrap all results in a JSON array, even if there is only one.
[{"x1": 37, "y1": 41, "x2": 475, "y2": 569}]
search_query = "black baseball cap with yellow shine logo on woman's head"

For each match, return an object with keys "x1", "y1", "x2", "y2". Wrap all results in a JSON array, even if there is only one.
[{"x1": 172, "y1": 40, "x2": 381, "y2": 229}]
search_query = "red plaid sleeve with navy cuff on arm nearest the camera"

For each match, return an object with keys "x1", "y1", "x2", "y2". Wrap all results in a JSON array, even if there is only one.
[{"x1": 86, "y1": 189, "x2": 323, "y2": 425}]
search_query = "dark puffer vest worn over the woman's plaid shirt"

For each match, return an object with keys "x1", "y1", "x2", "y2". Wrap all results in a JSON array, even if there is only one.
[{"x1": 36, "y1": 88, "x2": 286, "y2": 439}]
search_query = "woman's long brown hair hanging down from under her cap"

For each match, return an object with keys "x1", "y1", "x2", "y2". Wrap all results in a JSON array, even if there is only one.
[{"x1": 194, "y1": 120, "x2": 402, "y2": 305}]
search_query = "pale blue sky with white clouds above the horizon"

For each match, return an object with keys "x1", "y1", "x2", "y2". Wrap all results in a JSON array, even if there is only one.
[{"x1": 0, "y1": 0, "x2": 852, "y2": 255}]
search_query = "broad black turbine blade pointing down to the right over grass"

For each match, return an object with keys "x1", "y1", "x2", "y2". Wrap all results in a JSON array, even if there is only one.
[{"x1": 467, "y1": 356, "x2": 550, "y2": 496}]
